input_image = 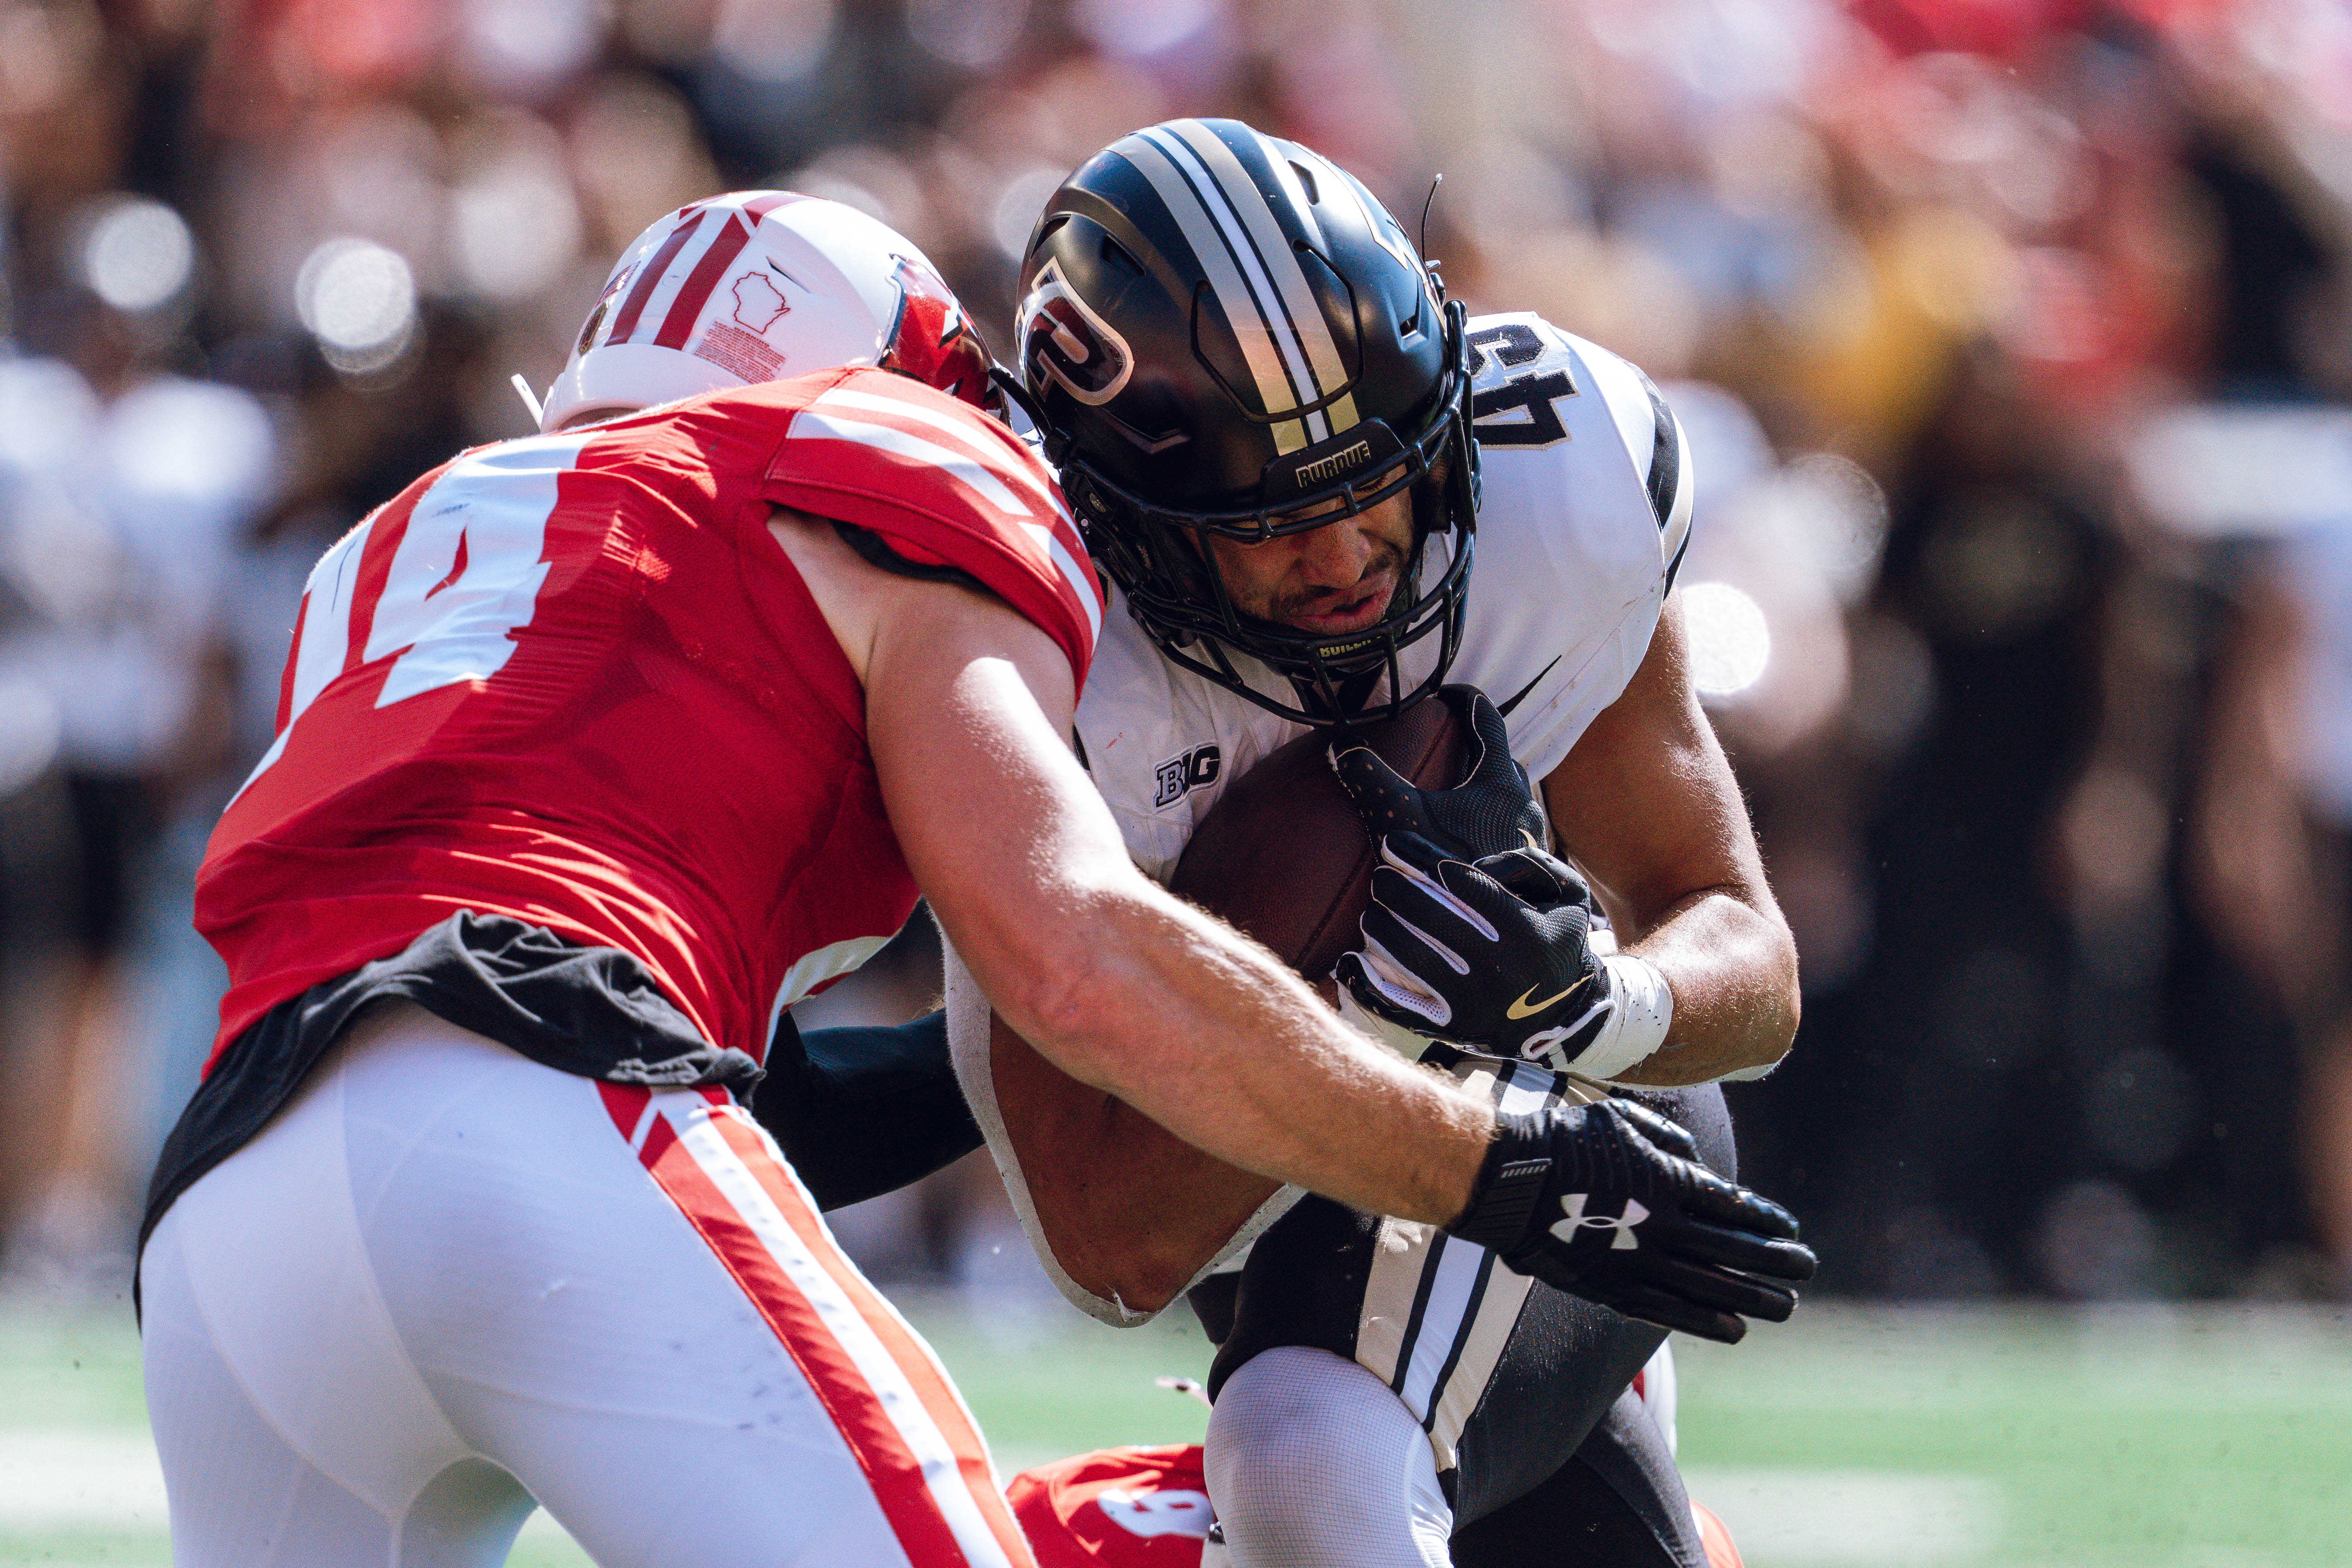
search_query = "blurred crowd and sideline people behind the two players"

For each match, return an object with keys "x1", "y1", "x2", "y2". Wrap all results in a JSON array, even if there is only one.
[{"x1": 0, "y1": 0, "x2": 2352, "y2": 1300}]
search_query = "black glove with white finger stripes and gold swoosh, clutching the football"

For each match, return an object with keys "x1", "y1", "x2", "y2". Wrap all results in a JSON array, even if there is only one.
[{"x1": 1334, "y1": 832, "x2": 1616, "y2": 1070}]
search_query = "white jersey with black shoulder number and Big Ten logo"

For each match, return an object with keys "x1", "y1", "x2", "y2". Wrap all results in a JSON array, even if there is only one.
[{"x1": 1077, "y1": 313, "x2": 1691, "y2": 882}]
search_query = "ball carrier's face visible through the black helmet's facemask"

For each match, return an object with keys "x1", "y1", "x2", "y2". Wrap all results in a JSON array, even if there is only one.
[{"x1": 1209, "y1": 465, "x2": 1414, "y2": 637}]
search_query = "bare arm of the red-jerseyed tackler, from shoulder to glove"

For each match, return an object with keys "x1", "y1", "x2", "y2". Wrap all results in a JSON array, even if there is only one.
[{"x1": 772, "y1": 512, "x2": 1493, "y2": 1225}]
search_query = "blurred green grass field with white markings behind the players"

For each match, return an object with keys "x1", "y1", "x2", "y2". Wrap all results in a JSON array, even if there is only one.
[{"x1": 0, "y1": 1298, "x2": 2352, "y2": 1568}]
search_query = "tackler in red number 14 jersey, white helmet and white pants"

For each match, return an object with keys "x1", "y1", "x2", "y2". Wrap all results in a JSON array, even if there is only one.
[{"x1": 141, "y1": 193, "x2": 1811, "y2": 1568}]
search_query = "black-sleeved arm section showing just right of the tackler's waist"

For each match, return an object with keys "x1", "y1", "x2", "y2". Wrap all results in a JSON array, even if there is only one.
[{"x1": 750, "y1": 1013, "x2": 981, "y2": 1208}]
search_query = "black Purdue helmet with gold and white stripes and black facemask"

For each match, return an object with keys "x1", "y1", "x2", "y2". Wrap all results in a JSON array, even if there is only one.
[{"x1": 1018, "y1": 120, "x2": 1477, "y2": 724}]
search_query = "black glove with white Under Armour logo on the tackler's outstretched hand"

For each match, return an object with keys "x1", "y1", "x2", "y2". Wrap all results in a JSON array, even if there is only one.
[{"x1": 1446, "y1": 1100, "x2": 1813, "y2": 1345}]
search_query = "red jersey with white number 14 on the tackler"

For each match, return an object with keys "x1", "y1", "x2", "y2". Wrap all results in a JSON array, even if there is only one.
[{"x1": 195, "y1": 369, "x2": 1101, "y2": 1070}]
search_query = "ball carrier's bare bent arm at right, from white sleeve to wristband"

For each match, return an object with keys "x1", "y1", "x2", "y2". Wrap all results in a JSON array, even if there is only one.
[{"x1": 1543, "y1": 595, "x2": 1797, "y2": 1086}]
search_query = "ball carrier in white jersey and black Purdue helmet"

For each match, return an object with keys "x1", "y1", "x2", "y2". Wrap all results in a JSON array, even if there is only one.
[{"x1": 948, "y1": 120, "x2": 1797, "y2": 1568}]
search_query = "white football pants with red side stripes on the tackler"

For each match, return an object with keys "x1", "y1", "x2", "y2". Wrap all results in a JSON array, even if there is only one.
[{"x1": 143, "y1": 1004, "x2": 1030, "y2": 1568}]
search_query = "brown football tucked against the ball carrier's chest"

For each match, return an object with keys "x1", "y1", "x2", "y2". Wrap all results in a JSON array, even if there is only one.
[{"x1": 1169, "y1": 698, "x2": 1472, "y2": 994}]
